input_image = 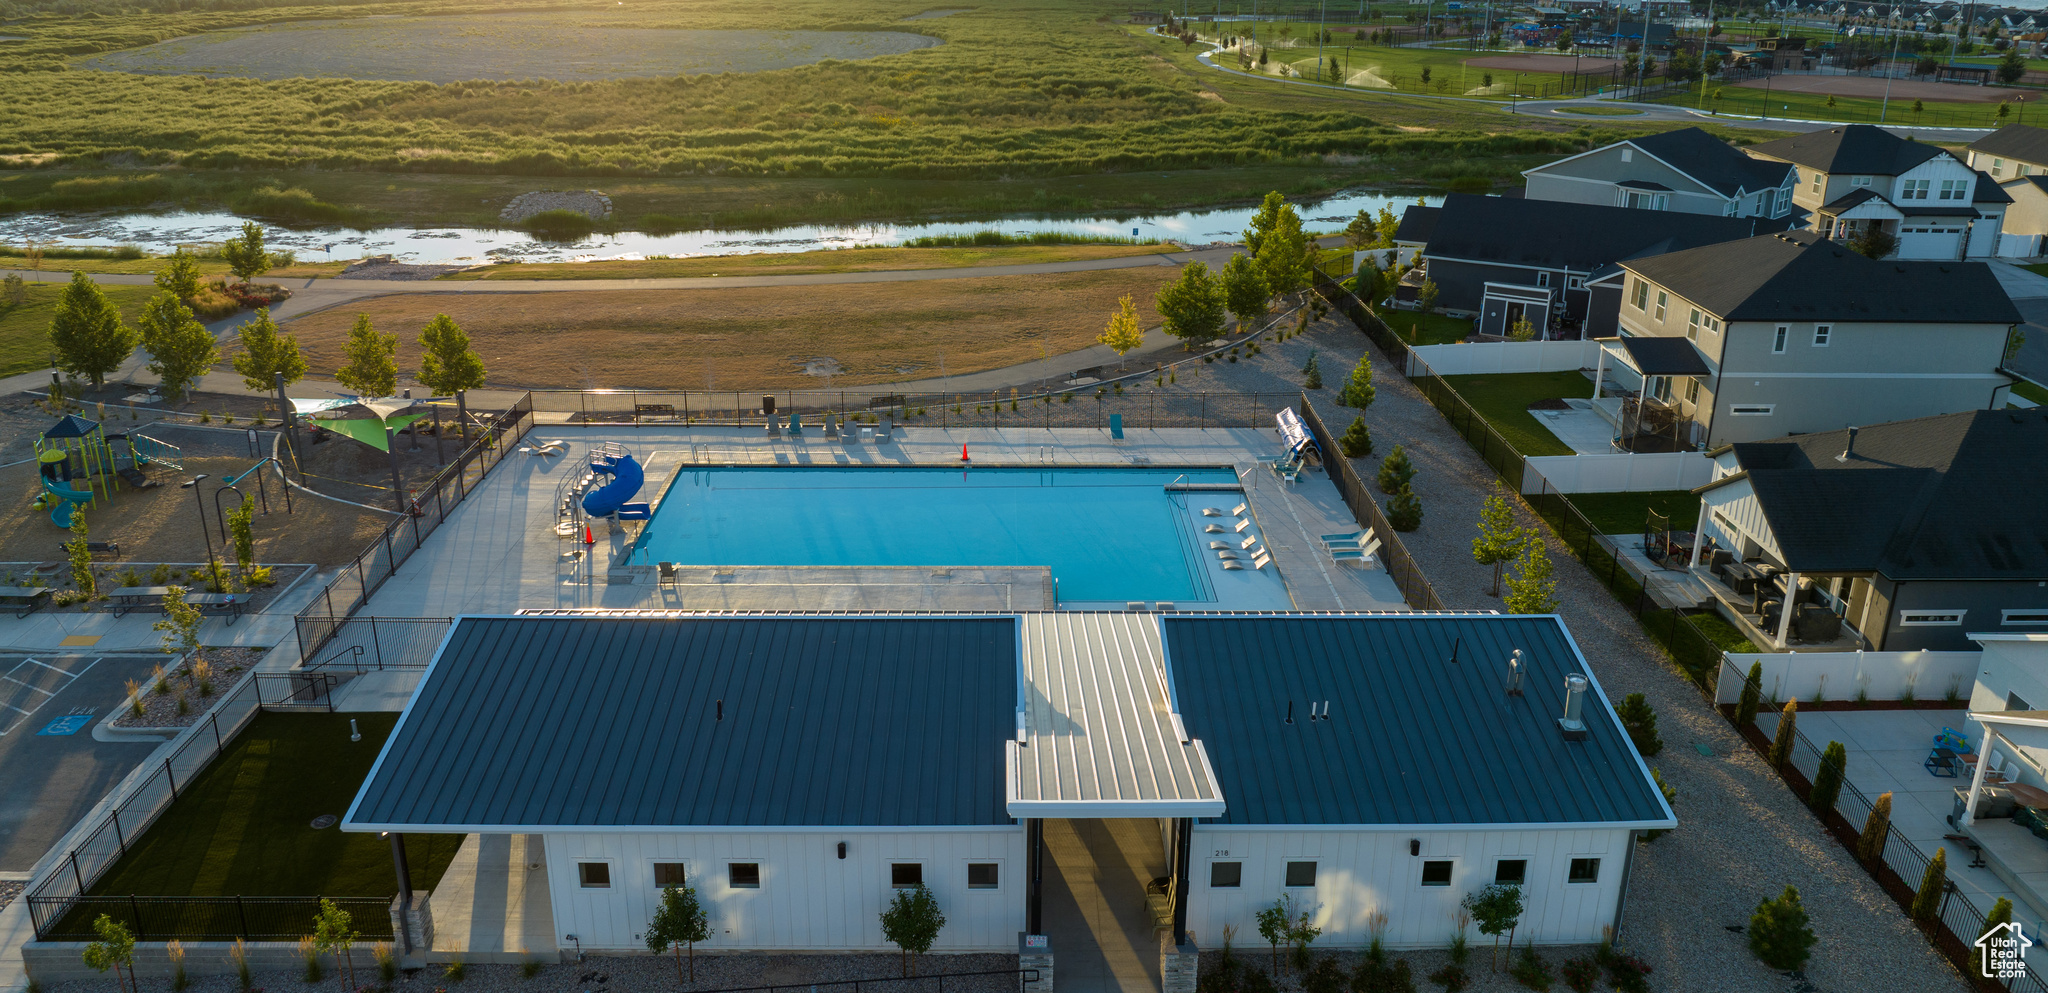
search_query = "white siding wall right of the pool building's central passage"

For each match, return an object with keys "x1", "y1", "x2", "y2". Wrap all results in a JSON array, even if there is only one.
[{"x1": 1188, "y1": 825, "x2": 1630, "y2": 948}]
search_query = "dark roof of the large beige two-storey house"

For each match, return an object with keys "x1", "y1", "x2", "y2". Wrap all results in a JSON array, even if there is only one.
[{"x1": 1624, "y1": 231, "x2": 2023, "y2": 323}]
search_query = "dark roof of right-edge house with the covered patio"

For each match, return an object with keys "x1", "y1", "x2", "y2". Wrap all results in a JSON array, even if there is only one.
[{"x1": 1736, "y1": 409, "x2": 2048, "y2": 581}]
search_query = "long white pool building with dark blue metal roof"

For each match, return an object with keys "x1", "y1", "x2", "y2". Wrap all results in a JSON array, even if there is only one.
[{"x1": 342, "y1": 610, "x2": 1677, "y2": 956}]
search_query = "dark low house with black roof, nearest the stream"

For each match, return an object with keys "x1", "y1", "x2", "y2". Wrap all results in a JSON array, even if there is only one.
[{"x1": 1395, "y1": 192, "x2": 1790, "y2": 338}]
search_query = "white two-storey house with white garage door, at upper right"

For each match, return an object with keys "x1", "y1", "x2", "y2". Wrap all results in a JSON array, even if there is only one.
[{"x1": 1749, "y1": 125, "x2": 2009, "y2": 260}]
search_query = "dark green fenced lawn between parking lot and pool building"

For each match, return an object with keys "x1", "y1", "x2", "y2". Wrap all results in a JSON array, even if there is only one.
[{"x1": 94, "y1": 713, "x2": 463, "y2": 897}]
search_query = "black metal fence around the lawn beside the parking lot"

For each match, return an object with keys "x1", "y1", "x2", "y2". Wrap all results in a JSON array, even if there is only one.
[{"x1": 27, "y1": 674, "x2": 374, "y2": 942}]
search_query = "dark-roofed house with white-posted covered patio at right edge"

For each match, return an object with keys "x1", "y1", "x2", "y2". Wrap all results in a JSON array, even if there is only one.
[{"x1": 1694, "y1": 409, "x2": 2048, "y2": 651}]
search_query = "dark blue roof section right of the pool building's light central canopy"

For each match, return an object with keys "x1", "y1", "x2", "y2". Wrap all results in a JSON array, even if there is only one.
[{"x1": 1161, "y1": 614, "x2": 1671, "y2": 825}]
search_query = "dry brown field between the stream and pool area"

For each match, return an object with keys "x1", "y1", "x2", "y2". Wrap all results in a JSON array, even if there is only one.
[{"x1": 289, "y1": 266, "x2": 1178, "y2": 389}]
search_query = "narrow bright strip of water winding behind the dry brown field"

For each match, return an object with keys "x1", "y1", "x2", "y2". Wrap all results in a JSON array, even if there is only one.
[{"x1": 0, "y1": 190, "x2": 1444, "y2": 262}]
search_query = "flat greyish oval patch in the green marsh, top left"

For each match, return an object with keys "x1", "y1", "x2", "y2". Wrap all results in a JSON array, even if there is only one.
[{"x1": 76, "y1": 14, "x2": 938, "y2": 82}]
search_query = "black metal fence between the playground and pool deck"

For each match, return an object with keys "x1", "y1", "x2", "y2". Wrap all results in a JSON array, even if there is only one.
[{"x1": 293, "y1": 393, "x2": 535, "y2": 661}]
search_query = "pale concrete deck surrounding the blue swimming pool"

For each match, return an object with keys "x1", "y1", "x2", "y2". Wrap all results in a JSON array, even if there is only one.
[{"x1": 348, "y1": 424, "x2": 1409, "y2": 616}]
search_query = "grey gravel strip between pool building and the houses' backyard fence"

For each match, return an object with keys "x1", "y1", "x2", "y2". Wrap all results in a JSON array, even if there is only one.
[{"x1": 1180, "y1": 305, "x2": 1968, "y2": 993}]
